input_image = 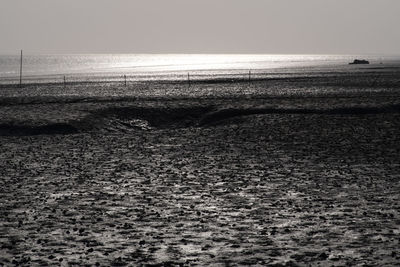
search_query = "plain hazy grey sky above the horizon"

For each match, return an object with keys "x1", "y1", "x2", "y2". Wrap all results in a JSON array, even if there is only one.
[{"x1": 0, "y1": 0, "x2": 400, "y2": 54}]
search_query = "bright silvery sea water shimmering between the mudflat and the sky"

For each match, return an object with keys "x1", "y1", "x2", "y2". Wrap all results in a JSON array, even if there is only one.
[{"x1": 0, "y1": 54, "x2": 400, "y2": 83}]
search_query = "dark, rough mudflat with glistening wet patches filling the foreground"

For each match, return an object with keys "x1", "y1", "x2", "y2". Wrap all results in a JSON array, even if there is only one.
[{"x1": 0, "y1": 74, "x2": 400, "y2": 266}]
